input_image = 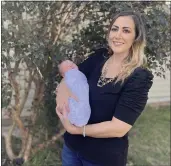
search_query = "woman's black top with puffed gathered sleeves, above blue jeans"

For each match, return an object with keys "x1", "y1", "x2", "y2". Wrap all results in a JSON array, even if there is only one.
[{"x1": 64, "y1": 48, "x2": 153, "y2": 166}]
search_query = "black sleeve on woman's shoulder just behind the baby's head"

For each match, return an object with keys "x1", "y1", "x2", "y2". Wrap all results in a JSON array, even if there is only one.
[{"x1": 78, "y1": 48, "x2": 107, "y2": 79}]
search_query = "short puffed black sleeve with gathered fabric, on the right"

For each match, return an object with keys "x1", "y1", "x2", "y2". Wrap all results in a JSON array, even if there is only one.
[{"x1": 114, "y1": 68, "x2": 153, "y2": 125}]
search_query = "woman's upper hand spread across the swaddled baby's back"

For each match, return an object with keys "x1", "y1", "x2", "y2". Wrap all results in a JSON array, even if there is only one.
[{"x1": 56, "y1": 80, "x2": 78, "y2": 113}]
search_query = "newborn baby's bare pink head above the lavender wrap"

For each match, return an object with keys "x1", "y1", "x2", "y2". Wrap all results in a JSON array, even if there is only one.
[{"x1": 58, "y1": 60, "x2": 78, "y2": 76}]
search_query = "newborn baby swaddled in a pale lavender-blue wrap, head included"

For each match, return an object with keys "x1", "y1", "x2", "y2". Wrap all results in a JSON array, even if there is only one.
[{"x1": 59, "y1": 60, "x2": 91, "y2": 127}]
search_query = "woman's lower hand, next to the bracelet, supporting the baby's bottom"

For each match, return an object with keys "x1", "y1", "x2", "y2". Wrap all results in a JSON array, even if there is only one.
[{"x1": 56, "y1": 106, "x2": 82, "y2": 134}]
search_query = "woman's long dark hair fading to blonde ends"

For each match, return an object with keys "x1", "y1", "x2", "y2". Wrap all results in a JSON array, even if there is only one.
[{"x1": 107, "y1": 11, "x2": 147, "y2": 83}]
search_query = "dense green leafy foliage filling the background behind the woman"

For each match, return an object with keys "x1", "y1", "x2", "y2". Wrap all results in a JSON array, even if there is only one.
[{"x1": 1, "y1": 1, "x2": 170, "y2": 165}]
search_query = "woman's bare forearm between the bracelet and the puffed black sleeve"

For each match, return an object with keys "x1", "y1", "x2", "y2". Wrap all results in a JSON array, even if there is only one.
[{"x1": 77, "y1": 121, "x2": 123, "y2": 138}]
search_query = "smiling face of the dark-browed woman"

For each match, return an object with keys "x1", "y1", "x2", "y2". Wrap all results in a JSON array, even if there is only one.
[{"x1": 108, "y1": 16, "x2": 135, "y2": 54}]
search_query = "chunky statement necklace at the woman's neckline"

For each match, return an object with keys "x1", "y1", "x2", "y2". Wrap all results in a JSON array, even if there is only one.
[{"x1": 97, "y1": 60, "x2": 116, "y2": 87}]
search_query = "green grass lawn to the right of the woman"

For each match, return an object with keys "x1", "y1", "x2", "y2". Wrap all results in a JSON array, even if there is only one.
[{"x1": 127, "y1": 106, "x2": 170, "y2": 166}]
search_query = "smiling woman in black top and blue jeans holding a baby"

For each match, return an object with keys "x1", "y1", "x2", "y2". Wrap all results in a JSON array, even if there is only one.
[{"x1": 56, "y1": 11, "x2": 153, "y2": 166}]
